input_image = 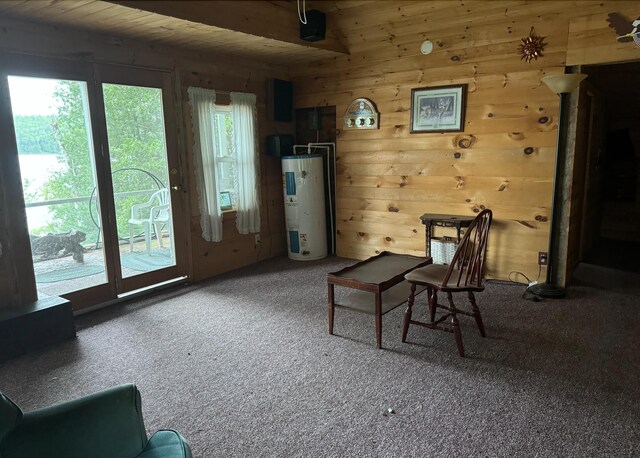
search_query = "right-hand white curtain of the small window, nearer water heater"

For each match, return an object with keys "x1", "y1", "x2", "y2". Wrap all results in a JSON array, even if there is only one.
[{"x1": 230, "y1": 92, "x2": 260, "y2": 234}]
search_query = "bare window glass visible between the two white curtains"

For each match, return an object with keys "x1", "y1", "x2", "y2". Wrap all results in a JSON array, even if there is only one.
[{"x1": 213, "y1": 105, "x2": 238, "y2": 209}]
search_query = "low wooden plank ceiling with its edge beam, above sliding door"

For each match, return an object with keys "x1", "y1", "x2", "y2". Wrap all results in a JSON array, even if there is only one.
[{"x1": 0, "y1": 0, "x2": 360, "y2": 64}]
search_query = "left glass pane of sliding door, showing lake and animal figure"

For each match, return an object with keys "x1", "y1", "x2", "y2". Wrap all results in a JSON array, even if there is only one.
[{"x1": 8, "y1": 76, "x2": 107, "y2": 296}]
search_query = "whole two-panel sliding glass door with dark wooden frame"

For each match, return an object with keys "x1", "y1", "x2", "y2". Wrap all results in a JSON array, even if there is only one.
[{"x1": 0, "y1": 56, "x2": 186, "y2": 308}]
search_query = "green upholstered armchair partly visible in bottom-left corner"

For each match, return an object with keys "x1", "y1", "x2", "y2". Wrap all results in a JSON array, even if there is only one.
[{"x1": 0, "y1": 384, "x2": 192, "y2": 458}]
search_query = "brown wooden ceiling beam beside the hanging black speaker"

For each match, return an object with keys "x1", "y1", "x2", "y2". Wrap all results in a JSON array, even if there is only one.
[{"x1": 108, "y1": 0, "x2": 349, "y2": 54}]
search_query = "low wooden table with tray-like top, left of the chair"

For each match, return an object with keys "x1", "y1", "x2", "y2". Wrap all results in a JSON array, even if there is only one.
[{"x1": 327, "y1": 251, "x2": 431, "y2": 348}]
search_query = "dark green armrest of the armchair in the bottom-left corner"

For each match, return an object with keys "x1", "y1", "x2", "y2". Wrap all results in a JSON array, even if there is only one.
[{"x1": 0, "y1": 384, "x2": 147, "y2": 458}]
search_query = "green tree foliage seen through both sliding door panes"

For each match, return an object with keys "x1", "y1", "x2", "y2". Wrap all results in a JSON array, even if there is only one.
[{"x1": 39, "y1": 81, "x2": 167, "y2": 241}]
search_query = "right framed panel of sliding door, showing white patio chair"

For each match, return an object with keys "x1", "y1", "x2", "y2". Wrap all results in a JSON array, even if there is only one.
[{"x1": 96, "y1": 62, "x2": 185, "y2": 292}]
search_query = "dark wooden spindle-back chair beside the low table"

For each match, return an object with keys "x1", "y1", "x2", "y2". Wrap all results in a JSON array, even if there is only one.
[{"x1": 402, "y1": 209, "x2": 493, "y2": 356}]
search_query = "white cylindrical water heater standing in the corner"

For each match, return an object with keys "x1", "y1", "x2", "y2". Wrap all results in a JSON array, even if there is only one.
[{"x1": 282, "y1": 154, "x2": 327, "y2": 260}]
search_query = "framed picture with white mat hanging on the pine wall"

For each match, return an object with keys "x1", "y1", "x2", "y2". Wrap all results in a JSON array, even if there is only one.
[{"x1": 411, "y1": 84, "x2": 467, "y2": 134}]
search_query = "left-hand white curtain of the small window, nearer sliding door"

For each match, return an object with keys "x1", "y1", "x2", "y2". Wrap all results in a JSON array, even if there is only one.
[{"x1": 187, "y1": 87, "x2": 222, "y2": 242}]
